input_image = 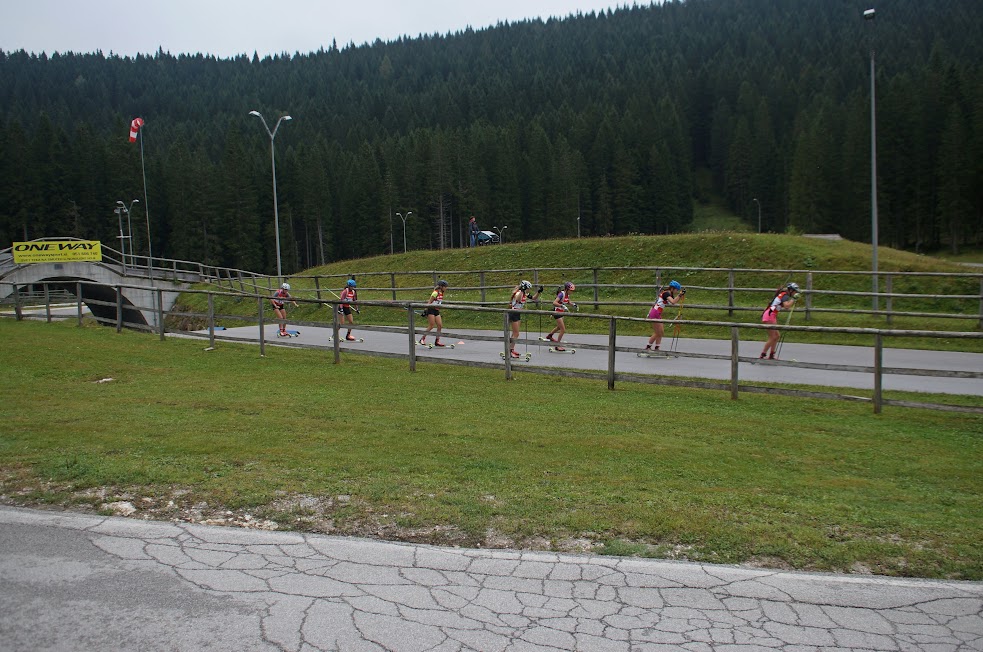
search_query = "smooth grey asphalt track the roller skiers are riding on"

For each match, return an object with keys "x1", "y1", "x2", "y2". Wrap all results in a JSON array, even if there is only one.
[{"x1": 199, "y1": 324, "x2": 983, "y2": 396}]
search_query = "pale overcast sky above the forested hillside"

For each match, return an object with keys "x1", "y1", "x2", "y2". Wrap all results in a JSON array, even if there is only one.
[{"x1": 0, "y1": 0, "x2": 636, "y2": 58}]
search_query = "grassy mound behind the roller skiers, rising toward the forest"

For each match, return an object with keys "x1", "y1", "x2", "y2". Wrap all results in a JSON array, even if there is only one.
[{"x1": 180, "y1": 232, "x2": 983, "y2": 351}]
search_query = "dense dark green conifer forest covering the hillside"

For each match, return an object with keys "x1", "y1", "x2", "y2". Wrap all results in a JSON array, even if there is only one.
[{"x1": 0, "y1": 0, "x2": 983, "y2": 273}]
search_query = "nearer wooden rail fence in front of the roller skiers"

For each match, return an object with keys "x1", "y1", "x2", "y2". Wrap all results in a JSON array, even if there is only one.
[{"x1": 0, "y1": 282, "x2": 983, "y2": 414}]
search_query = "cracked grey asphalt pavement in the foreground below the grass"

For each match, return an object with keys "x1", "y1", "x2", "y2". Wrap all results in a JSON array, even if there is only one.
[{"x1": 0, "y1": 507, "x2": 983, "y2": 652}]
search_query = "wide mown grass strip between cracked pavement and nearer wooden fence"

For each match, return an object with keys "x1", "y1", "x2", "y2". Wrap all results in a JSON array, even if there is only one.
[{"x1": 0, "y1": 319, "x2": 983, "y2": 580}]
